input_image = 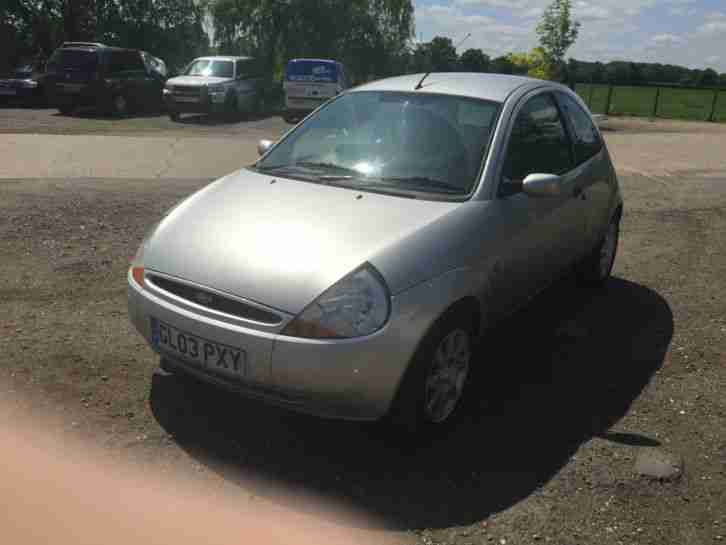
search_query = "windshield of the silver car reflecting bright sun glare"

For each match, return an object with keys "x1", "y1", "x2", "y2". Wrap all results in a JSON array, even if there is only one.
[{"x1": 255, "y1": 91, "x2": 500, "y2": 196}]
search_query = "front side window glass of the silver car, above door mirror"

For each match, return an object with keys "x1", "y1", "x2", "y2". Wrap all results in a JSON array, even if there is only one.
[{"x1": 500, "y1": 94, "x2": 573, "y2": 195}]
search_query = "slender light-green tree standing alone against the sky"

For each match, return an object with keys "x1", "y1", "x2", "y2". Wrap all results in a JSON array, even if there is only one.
[{"x1": 537, "y1": 0, "x2": 580, "y2": 79}]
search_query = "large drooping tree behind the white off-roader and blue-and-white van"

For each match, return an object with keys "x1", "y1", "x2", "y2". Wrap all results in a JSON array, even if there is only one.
[{"x1": 211, "y1": 0, "x2": 414, "y2": 83}]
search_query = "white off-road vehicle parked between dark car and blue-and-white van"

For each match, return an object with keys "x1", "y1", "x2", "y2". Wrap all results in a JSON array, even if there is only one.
[{"x1": 164, "y1": 57, "x2": 264, "y2": 121}]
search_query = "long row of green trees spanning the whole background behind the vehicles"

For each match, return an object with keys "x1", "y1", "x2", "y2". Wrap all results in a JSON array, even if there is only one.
[{"x1": 0, "y1": 0, "x2": 726, "y2": 87}]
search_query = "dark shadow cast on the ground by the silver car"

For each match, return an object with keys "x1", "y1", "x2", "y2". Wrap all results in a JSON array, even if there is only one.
[{"x1": 150, "y1": 279, "x2": 673, "y2": 530}]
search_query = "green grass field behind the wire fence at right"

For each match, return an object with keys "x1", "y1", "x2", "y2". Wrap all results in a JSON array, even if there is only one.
[{"x1": 576, "y1": 84, "x2": 726, "y2": 121}]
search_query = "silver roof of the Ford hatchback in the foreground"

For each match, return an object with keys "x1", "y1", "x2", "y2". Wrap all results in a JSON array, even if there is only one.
[{"x1": 351, "y1": 72, "x2": 567, "y2": 102}]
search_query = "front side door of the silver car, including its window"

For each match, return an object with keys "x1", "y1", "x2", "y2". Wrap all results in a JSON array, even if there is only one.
[{"x1": 489, "y1": 92, "x2": 584, "y2": 308}]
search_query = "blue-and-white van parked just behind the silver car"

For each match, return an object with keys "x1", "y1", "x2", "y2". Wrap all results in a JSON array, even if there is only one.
[{"x1": 283, "y1": 59, "x2": 350, "y2": 123}]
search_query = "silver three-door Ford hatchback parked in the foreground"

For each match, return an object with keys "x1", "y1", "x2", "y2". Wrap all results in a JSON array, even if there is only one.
[{"x1": 128, "y1": 73, "x2": 622, "y2": 429}]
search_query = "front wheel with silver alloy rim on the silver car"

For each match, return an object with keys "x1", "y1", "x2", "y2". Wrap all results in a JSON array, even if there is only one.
[{"x1": 385, "y1": 308, "x2": 476, "y2": 437}]
